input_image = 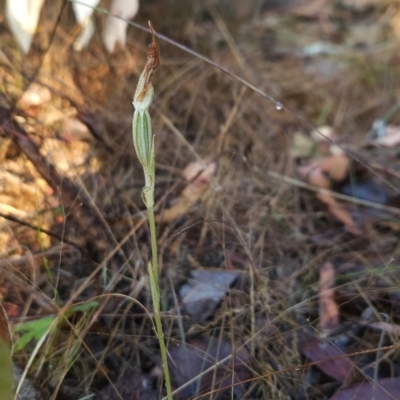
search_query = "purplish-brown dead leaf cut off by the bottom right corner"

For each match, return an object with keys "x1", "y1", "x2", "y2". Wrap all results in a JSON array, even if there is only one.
[{"x1": 330, "y1": 378, "x2": 400, "y2": 400}]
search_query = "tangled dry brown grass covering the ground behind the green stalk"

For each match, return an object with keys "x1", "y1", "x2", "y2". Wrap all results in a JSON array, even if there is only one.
[{"x1": 0, "y1": 1, "x2": 400, "y2": 399}]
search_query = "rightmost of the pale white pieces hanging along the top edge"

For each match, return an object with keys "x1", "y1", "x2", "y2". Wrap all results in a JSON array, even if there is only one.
[{"x1": 103, "y1": 0, "x2": 139, "y2": 53}]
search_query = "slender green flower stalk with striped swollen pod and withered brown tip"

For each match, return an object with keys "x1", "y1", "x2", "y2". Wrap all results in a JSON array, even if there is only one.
[{"x1": 132, "y1": 21, "x2": 172, "y2": 400}]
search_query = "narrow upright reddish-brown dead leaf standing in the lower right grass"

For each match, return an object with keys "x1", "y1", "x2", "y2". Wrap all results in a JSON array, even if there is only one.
[{"x1": 319, "y1": 261, "x2": 339, "y2": 335}]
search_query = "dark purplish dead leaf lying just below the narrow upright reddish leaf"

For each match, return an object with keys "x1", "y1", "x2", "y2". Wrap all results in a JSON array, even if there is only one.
[{"x1": 299, "y1": 334, "x2": 353, "y2": 383}]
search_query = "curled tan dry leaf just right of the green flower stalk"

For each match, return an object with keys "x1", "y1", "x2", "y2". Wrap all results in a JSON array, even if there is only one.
[{"x1": 156, "y1": 162, "x2": 217, "y2": 222}]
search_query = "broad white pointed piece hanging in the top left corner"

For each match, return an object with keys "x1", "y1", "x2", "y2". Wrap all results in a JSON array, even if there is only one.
[{"x1": 6, "y1": 0, "x2": 44, "y2": 54}]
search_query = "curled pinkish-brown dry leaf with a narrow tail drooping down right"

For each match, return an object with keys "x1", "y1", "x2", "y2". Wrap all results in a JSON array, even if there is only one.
[{"x1": 298, "y1": 154, "x2": 362, "y2": 235}]
